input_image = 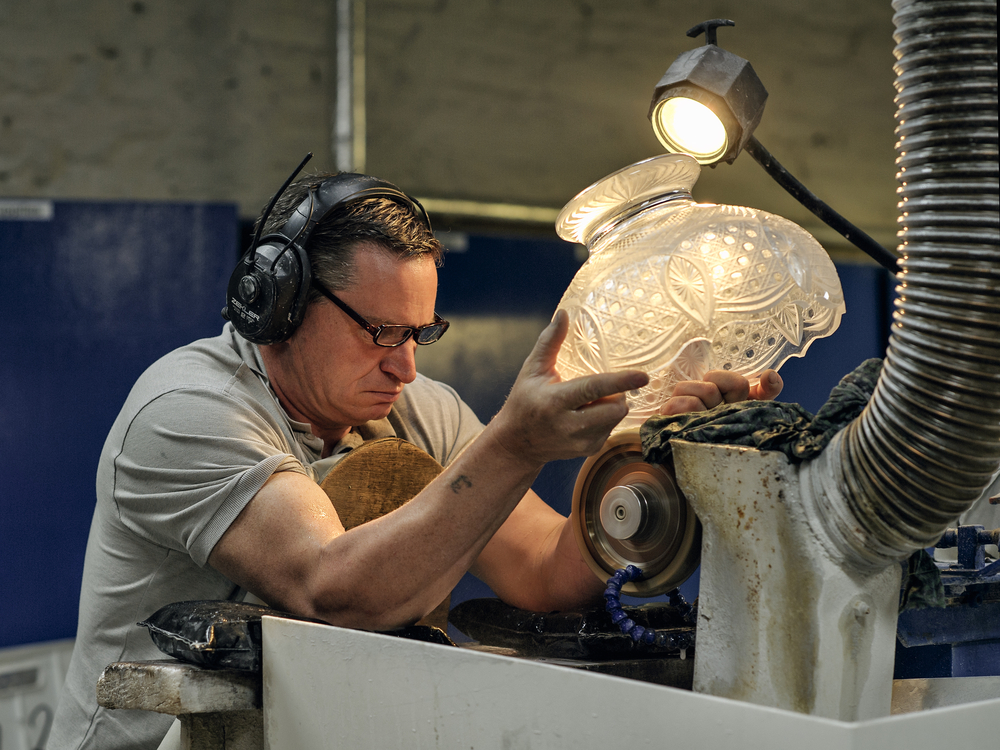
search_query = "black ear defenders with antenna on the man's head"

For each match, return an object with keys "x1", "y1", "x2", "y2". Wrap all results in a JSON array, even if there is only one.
[{"x1": 222, "y1": 159, "x2": 431, "y2": 344}]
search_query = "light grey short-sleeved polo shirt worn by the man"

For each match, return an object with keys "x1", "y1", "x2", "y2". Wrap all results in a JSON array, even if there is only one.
[{"x1": 48, "y1": 323, "x2": 483, "y2": 750}]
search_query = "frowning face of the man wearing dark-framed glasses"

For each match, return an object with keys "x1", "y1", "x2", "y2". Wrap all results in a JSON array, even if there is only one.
[{"x1": 277, "y1": 245, "x2": 437, "y2": 439}]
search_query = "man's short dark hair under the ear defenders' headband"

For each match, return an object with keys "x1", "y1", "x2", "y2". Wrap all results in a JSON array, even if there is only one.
[{"x1": 254, "y1": 173, "x2": 443, "y2": 304}]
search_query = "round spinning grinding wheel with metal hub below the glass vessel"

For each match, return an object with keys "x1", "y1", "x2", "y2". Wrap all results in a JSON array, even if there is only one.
[{"x1": 571, "y1": 430, "x2": 701, "y2": 596}]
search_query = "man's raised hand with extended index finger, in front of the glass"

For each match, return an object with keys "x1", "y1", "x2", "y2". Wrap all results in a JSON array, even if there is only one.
[{"x1": 490, "y1": 310, "x2": 649, "y2": 465}]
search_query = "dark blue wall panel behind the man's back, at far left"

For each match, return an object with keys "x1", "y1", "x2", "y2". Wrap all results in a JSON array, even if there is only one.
[{"x1": 0, "y1": 201, "x2": 238, "y2": 647}]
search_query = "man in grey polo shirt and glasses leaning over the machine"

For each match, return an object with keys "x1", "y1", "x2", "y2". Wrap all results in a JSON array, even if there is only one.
[{"x1": 50, "y1": 170, "x2": 780, "y2": 749}]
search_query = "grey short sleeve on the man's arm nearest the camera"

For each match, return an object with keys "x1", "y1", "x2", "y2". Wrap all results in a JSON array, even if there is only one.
[{"x1": 113, "y1": 388, "x2": 309, "y2": 565}]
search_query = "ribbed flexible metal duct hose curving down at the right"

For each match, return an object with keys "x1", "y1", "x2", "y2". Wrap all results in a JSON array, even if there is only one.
[{"x1": 826, "y1": 0, "x2": 1000, "y2": 567}]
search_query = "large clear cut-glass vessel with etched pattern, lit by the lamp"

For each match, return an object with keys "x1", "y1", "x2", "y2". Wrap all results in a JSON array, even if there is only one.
[{"x1": 556, "y1": 155, "x2": 844, "y2": 429}]
